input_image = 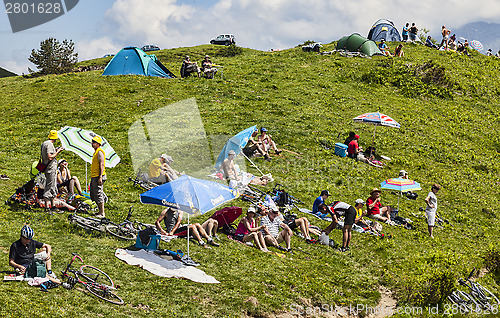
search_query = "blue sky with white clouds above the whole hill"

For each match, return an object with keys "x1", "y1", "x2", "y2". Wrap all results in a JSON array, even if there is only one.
[{"x1": 0, "y1": 0, "x2": 500, "y2": 74}]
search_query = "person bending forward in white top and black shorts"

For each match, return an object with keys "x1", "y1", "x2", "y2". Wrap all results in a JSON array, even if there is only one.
[{"x1": 318, "y1": 201, "x2": 356, "y2": 252}]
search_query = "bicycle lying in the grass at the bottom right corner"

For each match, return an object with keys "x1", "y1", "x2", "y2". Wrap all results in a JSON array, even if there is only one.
[{"x1": 448, "y1": 268, "x2": 500, "y2": 314}]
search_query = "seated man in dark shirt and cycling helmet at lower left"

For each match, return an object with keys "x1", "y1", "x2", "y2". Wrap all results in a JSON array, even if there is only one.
[{"x1": 9, "y1": 225, "x2": 56, "y2": 279}]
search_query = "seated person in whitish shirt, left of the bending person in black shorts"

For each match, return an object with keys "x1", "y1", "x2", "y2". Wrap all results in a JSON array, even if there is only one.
[{"x1": 260, "y1": 208, "x2": 293, "y2": 252}]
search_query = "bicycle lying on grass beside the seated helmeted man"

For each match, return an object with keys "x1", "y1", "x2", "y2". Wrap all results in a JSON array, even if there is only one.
[{"x1": 61, "y1": 253, "x2": 123, "y2": 305}]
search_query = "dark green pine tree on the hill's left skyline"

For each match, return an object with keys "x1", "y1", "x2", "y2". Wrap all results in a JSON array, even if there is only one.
[{"x1": 28, "y1": 38, "x2": 78, "y2": 75}]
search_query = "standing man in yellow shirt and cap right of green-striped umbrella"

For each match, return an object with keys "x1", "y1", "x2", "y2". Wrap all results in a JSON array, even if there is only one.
[{"x1": 90, "y1": 136, "x2": 106, "y2": 218}]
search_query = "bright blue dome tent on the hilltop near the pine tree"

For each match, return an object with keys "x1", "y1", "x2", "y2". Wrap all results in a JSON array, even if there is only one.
[{"x1": 102, "y1": 46, "x2": 175, "y2": 78}]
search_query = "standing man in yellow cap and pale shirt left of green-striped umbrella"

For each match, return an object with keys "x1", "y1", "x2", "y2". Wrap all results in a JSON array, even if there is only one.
[{"x1": 40, "y1": 130, "x2": 64, "y2": 214}]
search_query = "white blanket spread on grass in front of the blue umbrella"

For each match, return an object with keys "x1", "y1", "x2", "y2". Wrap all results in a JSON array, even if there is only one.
[{"x1": 115, "y1": 248, "x2": 220, "y2": 284}]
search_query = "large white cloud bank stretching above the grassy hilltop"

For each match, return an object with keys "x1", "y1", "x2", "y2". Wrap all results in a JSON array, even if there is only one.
[{"x1": 96, "y1": 0, "x2": 500, "y2": 50}]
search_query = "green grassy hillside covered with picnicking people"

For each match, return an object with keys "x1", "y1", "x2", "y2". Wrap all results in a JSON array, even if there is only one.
[{"x1": 0, "y1": 44, "x2": 500, "y2": 317}]
